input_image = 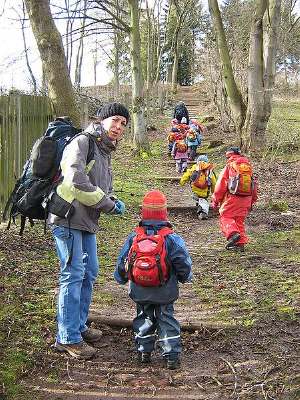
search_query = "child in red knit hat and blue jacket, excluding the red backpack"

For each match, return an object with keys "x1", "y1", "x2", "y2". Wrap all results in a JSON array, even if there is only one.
[{"x1": 114, "y1": 190, "x2": 192, "y2": 369}]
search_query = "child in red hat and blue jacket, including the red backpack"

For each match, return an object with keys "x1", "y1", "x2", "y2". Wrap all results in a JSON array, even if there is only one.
[{"x1": 114, "y1": 190, "x2": 192, "y2": 369}]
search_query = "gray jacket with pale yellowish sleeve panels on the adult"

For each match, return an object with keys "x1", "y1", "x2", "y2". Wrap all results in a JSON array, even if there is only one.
[{"x1": 48, "y1": 124, "x2": 115, "y2": 233}]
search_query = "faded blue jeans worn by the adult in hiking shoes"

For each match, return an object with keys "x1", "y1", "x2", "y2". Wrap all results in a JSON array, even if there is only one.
[{"x1": 52, "y1": 226, "x2": 99, "y2": 344}]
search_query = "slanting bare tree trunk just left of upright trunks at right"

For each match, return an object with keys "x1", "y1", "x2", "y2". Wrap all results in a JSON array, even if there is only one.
[{"x1": 208, "y1": 0, "x2": 246, "y2": 137}]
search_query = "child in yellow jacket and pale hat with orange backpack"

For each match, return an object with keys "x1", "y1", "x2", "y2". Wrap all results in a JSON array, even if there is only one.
[{"x1": 179, "y1": 154, "x2": 217, "y2": 219}]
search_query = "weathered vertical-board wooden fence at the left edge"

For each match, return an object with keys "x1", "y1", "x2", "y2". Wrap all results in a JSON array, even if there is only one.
[{"x1": 0, "y1": 95, "x2": 52, "y2": 220}]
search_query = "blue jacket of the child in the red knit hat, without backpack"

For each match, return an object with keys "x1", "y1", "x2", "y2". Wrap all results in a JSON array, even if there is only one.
[{"x1": 114, "y1": 220, "x2": 192, "y2": 304}]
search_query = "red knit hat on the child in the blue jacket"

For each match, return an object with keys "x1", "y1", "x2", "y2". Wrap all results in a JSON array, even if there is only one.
[{"x1": 142, "y1": 190, "x2": 168, "y2": 221}]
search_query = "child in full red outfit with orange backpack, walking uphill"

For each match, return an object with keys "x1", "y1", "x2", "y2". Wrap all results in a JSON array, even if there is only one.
[{"x1": 211, "y1": 147, "x2": 257, "y2": 252}]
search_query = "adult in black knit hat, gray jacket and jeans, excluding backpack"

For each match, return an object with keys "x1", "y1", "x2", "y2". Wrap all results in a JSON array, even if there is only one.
[{"x1": 48, "y1": 103, "x2": 129, "y2": 359}]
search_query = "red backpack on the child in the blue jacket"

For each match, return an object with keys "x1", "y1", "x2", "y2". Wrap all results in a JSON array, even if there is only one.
[{"x1": 127, "y1": 226, "x2": 174, "y2": 287}]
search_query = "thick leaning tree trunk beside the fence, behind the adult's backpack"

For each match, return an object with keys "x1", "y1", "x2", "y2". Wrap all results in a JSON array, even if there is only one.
[{"x1": 25, "y1": 0, "x2": 80, "y2": 125}]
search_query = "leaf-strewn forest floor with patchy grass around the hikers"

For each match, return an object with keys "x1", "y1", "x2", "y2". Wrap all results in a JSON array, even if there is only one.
[{"x1": 0, "y1": 104, "x2": 300, "y2": 400}]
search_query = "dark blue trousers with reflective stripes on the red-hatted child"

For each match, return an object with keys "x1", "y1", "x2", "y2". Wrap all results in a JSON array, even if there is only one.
[{"x1": 132, "y1": 303, "x2": 181, "y2": 356}]
